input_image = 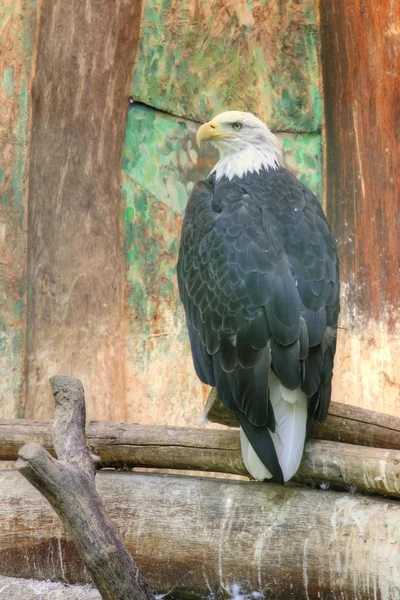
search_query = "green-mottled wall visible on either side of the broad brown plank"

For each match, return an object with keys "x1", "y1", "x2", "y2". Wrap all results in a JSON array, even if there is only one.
[{"x1": 0, "y1": 0, "x2": 322, "y2": 424}]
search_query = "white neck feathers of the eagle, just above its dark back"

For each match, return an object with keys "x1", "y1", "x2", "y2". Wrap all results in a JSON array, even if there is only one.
[{"x1": 210, "y1": 138, "x2": 282, "y2": 181}]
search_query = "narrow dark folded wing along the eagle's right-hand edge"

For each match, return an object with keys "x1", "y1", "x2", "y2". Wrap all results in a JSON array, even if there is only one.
[{"x1": 286, "y1": 173, "x2": 340, "y2": 422}]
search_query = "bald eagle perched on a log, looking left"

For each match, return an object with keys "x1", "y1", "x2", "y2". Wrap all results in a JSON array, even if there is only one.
[{"x1": 177, "y1": 111, "x2": 339, "y2": 482}]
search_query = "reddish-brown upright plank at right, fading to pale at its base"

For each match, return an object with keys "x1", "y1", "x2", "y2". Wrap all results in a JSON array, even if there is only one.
[{"x1": 320, "y1": 0, "x2": 400, "y2": 416}]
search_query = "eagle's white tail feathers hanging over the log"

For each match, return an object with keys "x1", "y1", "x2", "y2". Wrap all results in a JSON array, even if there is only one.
[{"x1": 240, "y1": 372, "x2": 307, "y2": 481}]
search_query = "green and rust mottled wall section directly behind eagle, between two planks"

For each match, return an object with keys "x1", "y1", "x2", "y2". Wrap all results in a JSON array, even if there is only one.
[{"x1": 122, "y1": 0, "x2": 322, "y2": 425}]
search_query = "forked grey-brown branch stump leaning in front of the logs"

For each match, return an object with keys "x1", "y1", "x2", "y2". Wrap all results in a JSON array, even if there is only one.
[{"x1": 16, "y1": 376, "x2": 154, "y2": 600}]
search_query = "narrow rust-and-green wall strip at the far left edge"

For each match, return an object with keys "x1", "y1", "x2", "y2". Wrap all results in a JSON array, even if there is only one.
[{"x1": 0, "y1": 0, "x2": 36, "y2": 418}]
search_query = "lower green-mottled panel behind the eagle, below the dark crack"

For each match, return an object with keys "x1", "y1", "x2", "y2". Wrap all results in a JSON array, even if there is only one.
[{"x1": 122, "y1": 104, "x2": 321, "y2": 425}]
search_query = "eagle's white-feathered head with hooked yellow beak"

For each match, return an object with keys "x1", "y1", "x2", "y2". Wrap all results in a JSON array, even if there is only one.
[{"x1": 196, "y1": 110, "x2": 282, "y2": 181}]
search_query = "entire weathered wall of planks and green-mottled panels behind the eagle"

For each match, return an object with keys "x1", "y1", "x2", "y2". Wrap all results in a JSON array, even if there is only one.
[{"x1": 0, "y1": 0, "x2": 400, "y2": 425}]
